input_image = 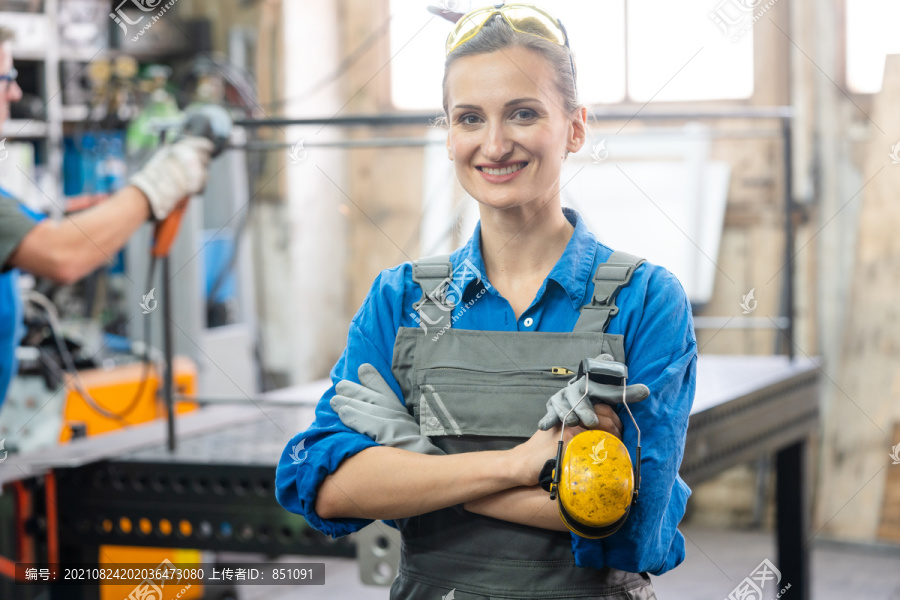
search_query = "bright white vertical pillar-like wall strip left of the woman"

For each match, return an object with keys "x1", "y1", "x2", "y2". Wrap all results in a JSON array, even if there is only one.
[{"x1": 272, "y1": 2, "x2": 355, "y2": 384}]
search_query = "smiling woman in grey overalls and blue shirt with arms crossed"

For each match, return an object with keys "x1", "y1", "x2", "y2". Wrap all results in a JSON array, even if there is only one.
[{"x1": 276, "y1": 5, "x2": 696, "y2": 600}]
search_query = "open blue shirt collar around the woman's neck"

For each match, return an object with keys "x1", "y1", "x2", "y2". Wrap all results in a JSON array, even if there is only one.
[{"x1": 452, "y1": 208, "x2": 597, "y2": 309}]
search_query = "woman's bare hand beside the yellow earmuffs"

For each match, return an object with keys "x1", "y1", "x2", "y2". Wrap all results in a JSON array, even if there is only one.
[{"x1": 508, "y1": 404, "x2": 622, "y2": 486}]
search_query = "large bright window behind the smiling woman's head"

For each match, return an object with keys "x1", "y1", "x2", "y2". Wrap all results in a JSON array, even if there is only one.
[{"x1": 390, "y1": 0, "x2": 763, "y2": 110}]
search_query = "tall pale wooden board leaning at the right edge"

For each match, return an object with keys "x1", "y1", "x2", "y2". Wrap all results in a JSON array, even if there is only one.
[{"x1": 818, "y1": 54, "x2": 900, "y2": 541}]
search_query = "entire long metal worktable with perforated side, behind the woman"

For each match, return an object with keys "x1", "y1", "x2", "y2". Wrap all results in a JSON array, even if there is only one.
[{"x1": 0, "y1": 355, "x2": 819, "y2": 600}]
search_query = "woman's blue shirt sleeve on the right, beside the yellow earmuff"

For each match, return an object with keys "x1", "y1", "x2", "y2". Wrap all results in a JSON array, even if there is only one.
[{"x1": 572, "y1": 265, "x2": 697, "y2": 575}]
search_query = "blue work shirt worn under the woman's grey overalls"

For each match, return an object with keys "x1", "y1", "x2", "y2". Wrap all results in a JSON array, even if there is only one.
[{"x1": 275, "y1": 209, "x2": 697, "y2": 575}]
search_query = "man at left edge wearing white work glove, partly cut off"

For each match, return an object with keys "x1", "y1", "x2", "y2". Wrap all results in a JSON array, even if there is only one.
[{"x1": 0, "y1": 26, "x2": 213, "y2": 406}]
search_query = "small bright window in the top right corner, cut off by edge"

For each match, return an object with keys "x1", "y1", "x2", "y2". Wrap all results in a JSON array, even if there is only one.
[{"x1": 846, "y1": 0, "x2": 900, "y2": 94}]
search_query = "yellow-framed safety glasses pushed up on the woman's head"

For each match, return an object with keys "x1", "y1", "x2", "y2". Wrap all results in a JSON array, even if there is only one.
[{"x1": 447, "y1": 3, "x2": 569, "y2": 56}]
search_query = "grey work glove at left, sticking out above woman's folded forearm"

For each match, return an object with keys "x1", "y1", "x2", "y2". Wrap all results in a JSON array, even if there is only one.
[{"x1": 331, "y1": 363, "x2": 444, "y2": 454}]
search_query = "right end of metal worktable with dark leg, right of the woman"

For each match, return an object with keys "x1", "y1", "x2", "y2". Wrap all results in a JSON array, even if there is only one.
[{"x1": 681, "y1": 356, "x2": 821, "y2": 600}]
